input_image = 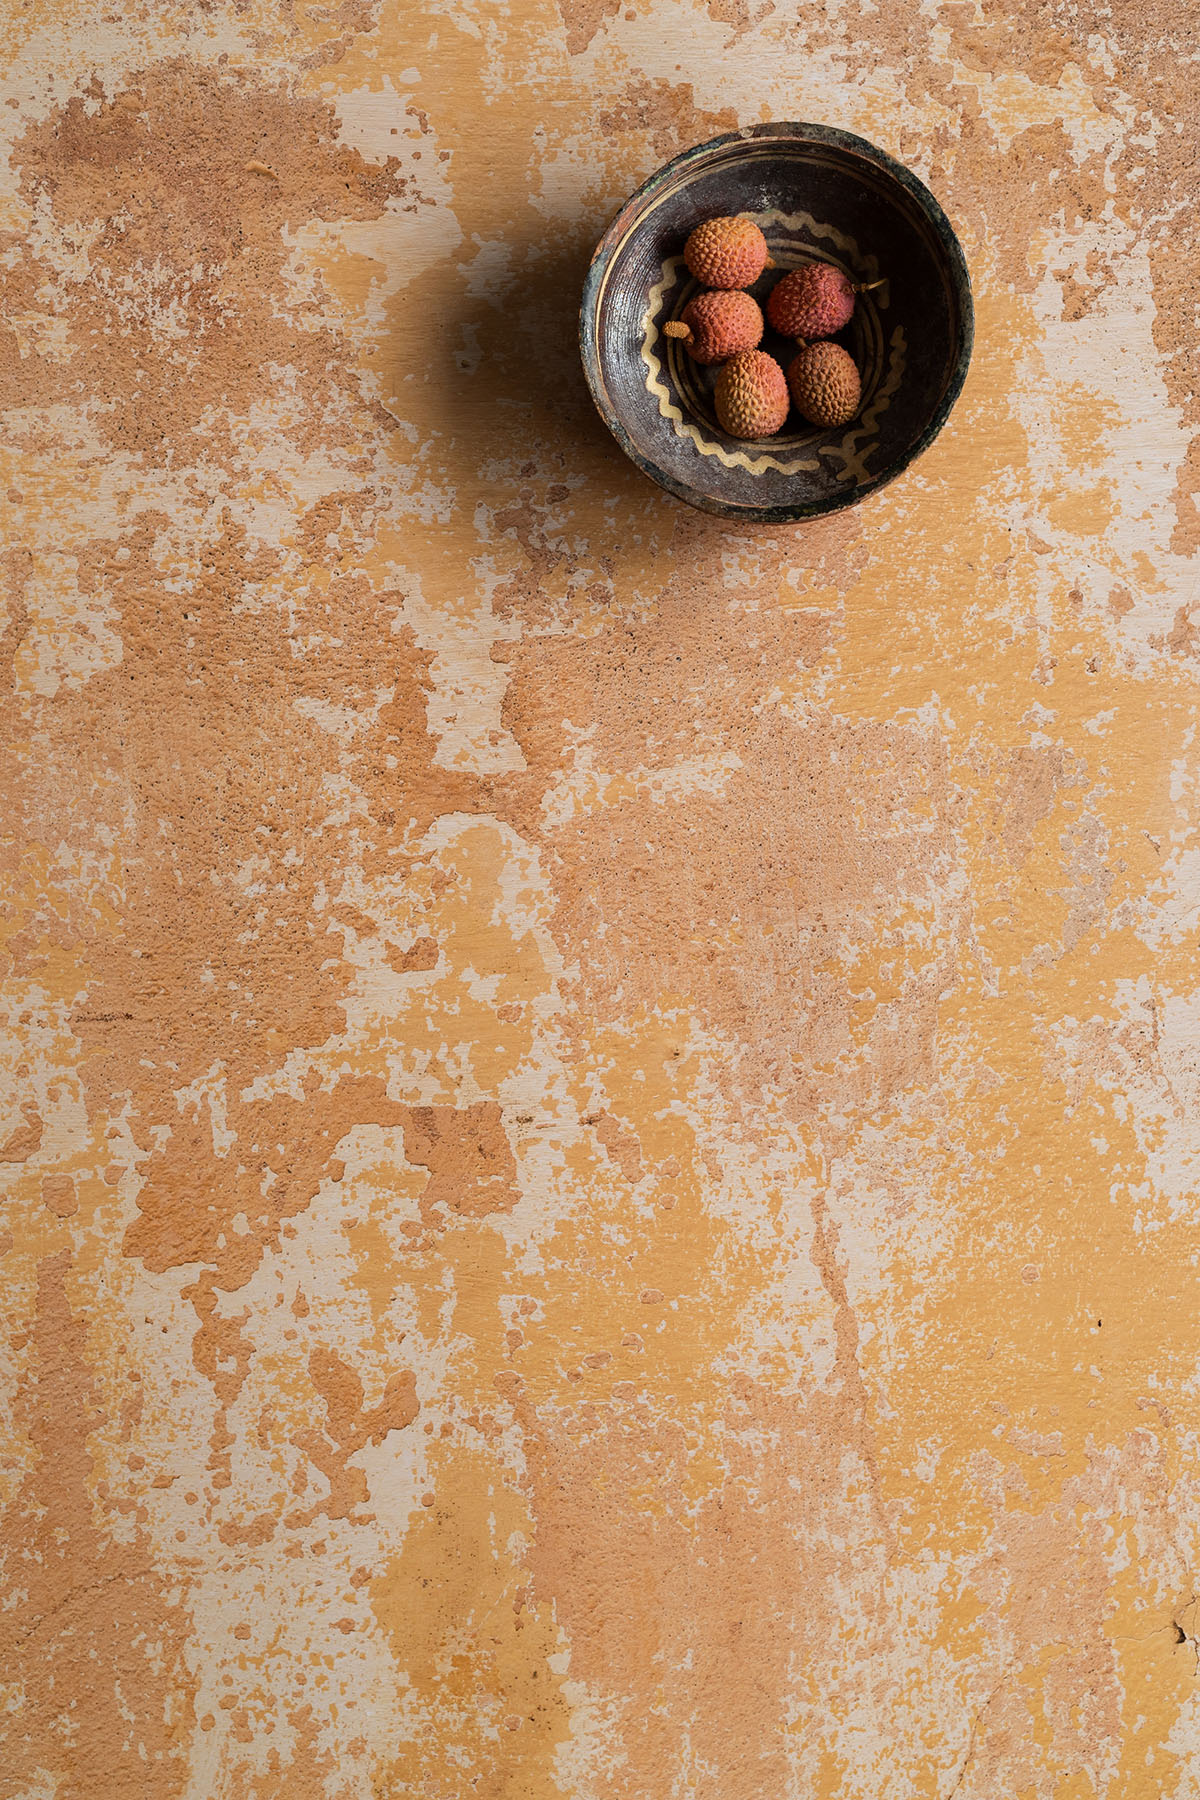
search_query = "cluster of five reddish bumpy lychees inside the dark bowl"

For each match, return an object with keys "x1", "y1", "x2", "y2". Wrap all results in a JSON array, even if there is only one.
[{"x1": 662, "y1": 218, "x2": 878, "y2": 437}]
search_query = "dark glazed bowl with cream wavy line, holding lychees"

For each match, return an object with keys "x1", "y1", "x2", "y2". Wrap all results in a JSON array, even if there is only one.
[{"x1": 579, "y1": 124, "x2": 973, "y2": 522}]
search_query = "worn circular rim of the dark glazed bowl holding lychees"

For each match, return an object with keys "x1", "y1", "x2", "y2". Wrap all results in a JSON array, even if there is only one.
[{"x1": 579, "y1": 119, "x2": 975, "y2": 524}]
